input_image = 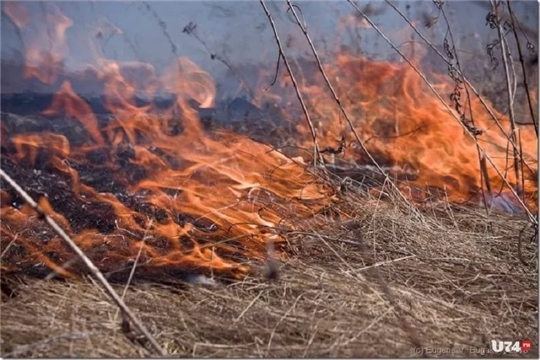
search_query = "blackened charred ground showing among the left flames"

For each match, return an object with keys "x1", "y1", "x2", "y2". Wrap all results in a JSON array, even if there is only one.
[{"x1": 0, "y1": 100, "x2": 310, "y2": 280}]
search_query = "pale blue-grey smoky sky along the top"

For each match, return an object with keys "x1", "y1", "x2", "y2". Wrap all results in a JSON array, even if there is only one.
[{"x1": 1, "y1": 0, "x2": 538, "y2": 94}]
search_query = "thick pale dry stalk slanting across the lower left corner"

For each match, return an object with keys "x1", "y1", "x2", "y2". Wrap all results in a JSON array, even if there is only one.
[{"x1": 0, "y1": 169, "x2": 166, "y2": 356}]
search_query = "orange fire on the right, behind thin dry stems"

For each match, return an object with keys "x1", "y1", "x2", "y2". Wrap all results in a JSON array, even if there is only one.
[{"x1": 262, "y1": 53, "x2": 538, "y2": 211}]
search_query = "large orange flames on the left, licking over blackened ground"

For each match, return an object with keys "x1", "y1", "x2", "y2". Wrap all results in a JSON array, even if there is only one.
[{"x1": 0, "y1": 3, "x2": 332, "y2": 276}]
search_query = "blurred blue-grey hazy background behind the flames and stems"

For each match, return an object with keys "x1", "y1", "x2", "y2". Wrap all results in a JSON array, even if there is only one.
[{"x1": 1, "y1": 0, "x2": 538, "y2": 103}]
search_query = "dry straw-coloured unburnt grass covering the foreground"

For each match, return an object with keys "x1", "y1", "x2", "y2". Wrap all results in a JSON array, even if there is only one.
[{"x1": 1, "y1": 179, "x2": 538, "y2": 357}]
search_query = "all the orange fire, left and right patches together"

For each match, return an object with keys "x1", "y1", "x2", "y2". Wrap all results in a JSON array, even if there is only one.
[{"x1": 0, "y1": 2, "x2": 537, "y2": 276}]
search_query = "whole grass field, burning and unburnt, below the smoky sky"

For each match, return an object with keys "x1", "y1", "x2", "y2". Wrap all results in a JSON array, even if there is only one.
[{"x1": 0, "y1": 1, "x2": 538, "y2": 357}]
